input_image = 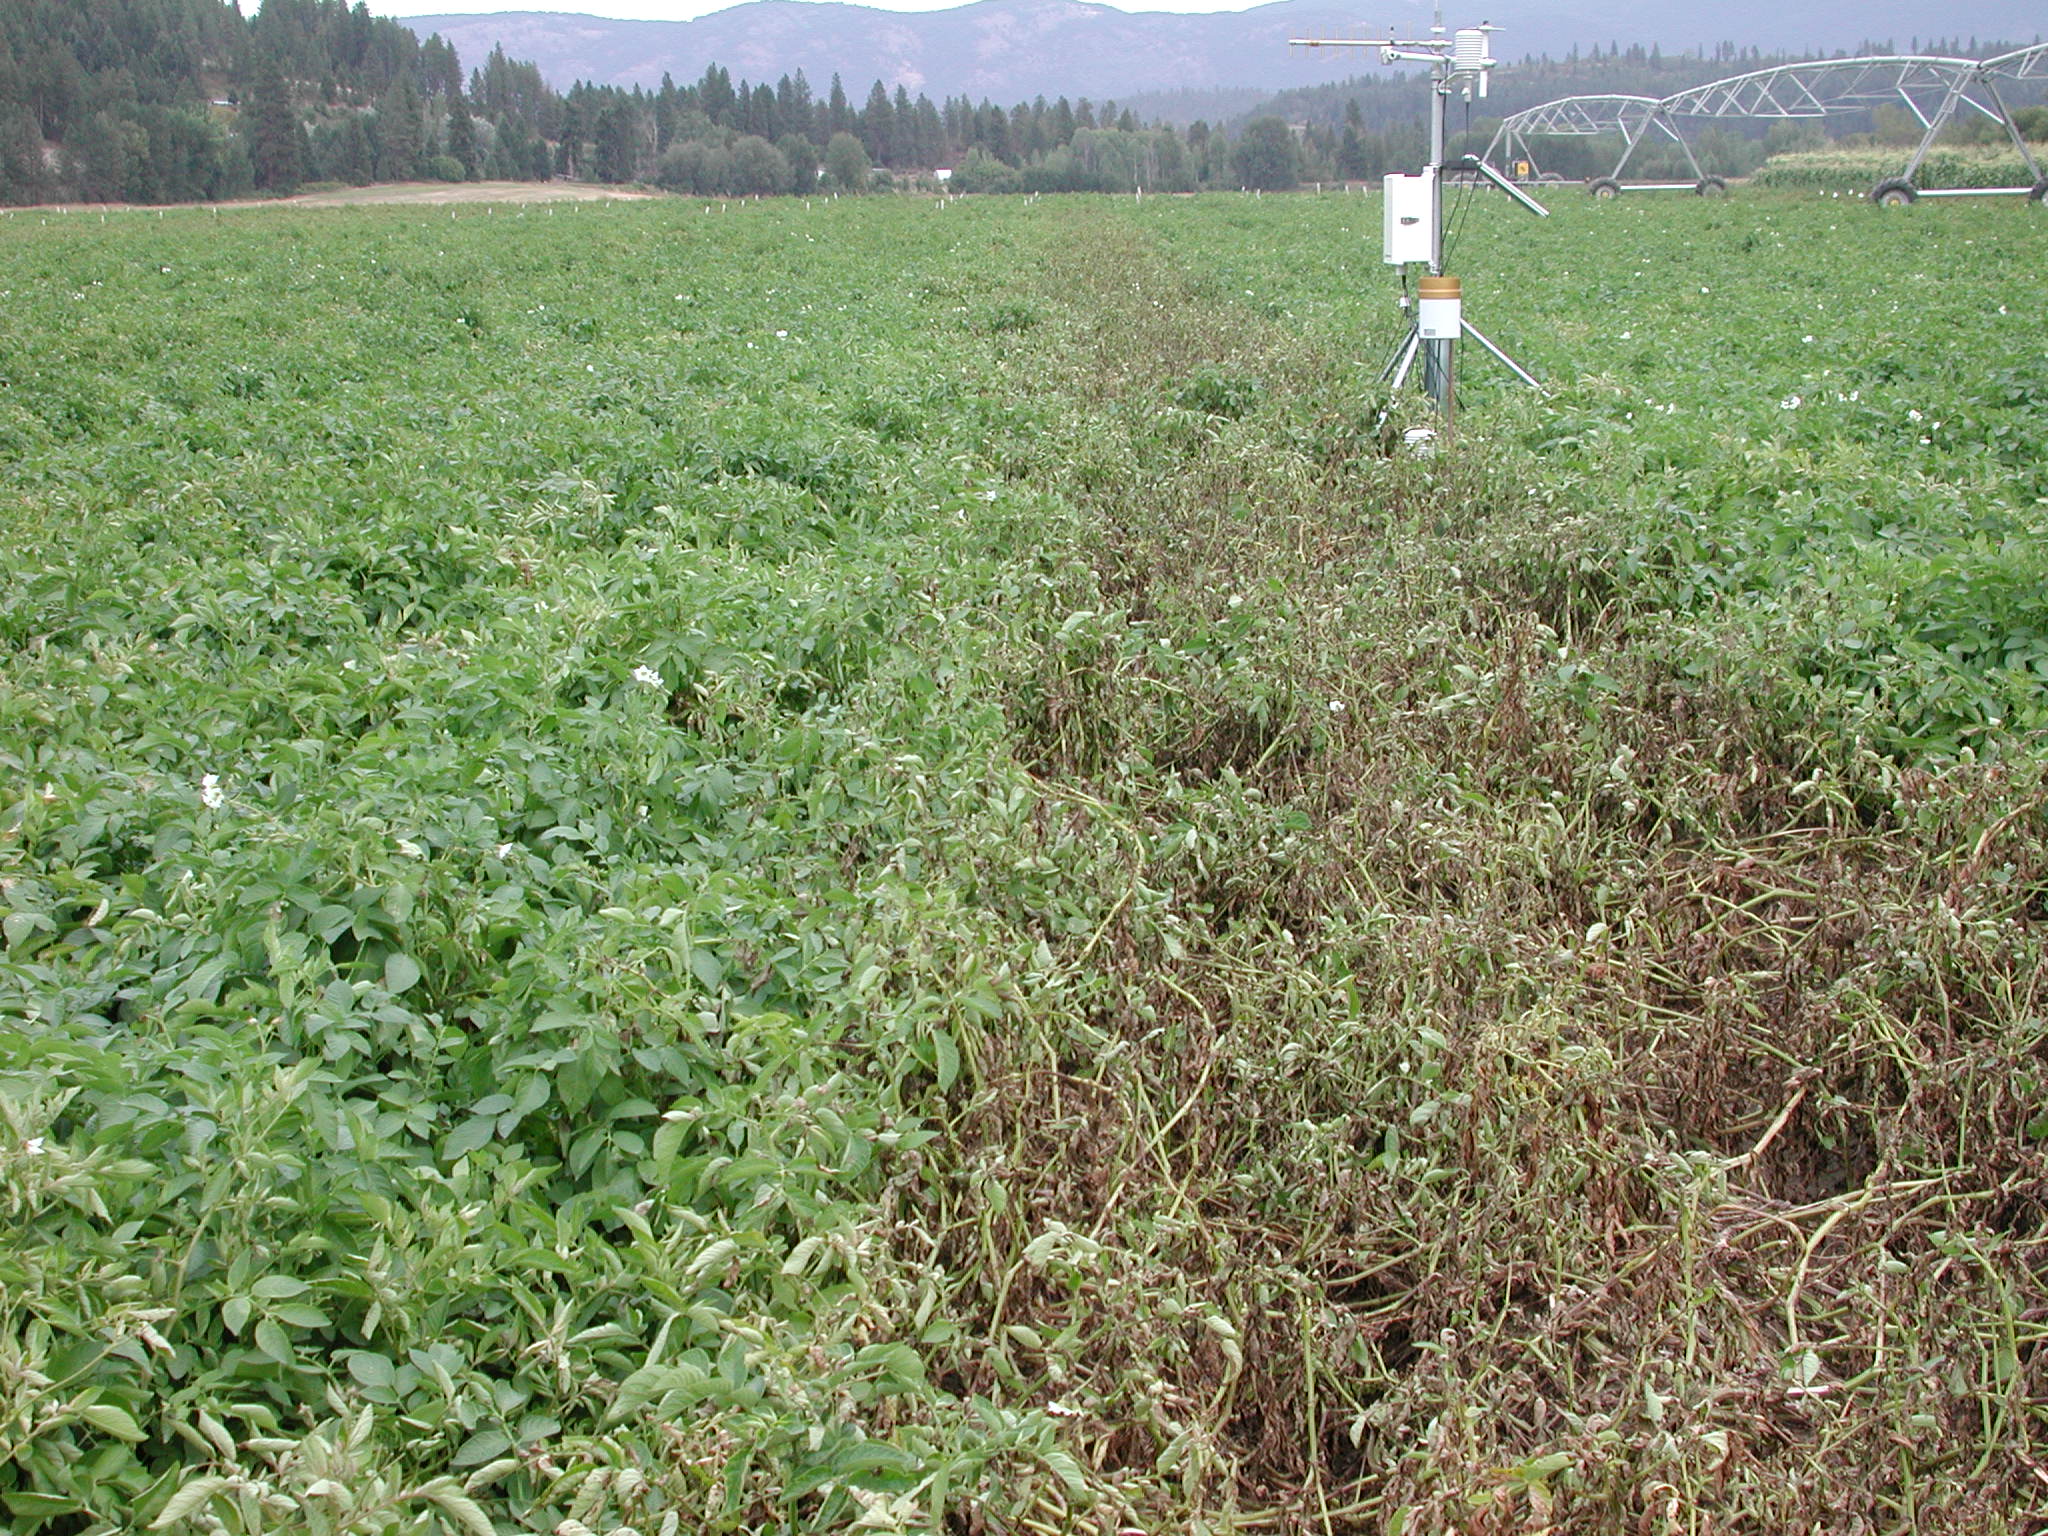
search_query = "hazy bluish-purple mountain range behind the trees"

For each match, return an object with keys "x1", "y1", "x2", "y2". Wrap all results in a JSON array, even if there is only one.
[{"x1": 406, "y1": 0, "x2": 2044, "y2": 106}]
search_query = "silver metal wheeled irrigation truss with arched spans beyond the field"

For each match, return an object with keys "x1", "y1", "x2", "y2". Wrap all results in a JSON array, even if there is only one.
[{"x1": 1485, "y1": 43, "x2": 2048, "y2": 203}]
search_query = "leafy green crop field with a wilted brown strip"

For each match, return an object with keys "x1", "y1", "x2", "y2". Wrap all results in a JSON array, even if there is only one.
[{"x1": 0, "y1": 197, "x2": 2048, "y2": 1536}]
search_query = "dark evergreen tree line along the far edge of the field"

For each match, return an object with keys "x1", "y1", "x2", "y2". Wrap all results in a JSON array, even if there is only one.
[{"x1": 12, "y1": 0, "x2": 2031, "y2": 203}]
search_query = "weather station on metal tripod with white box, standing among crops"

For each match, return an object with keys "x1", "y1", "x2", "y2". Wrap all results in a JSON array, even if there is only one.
[{"x1": 1288, "y1": 8, "x2": 1550, "y2": 424}]
